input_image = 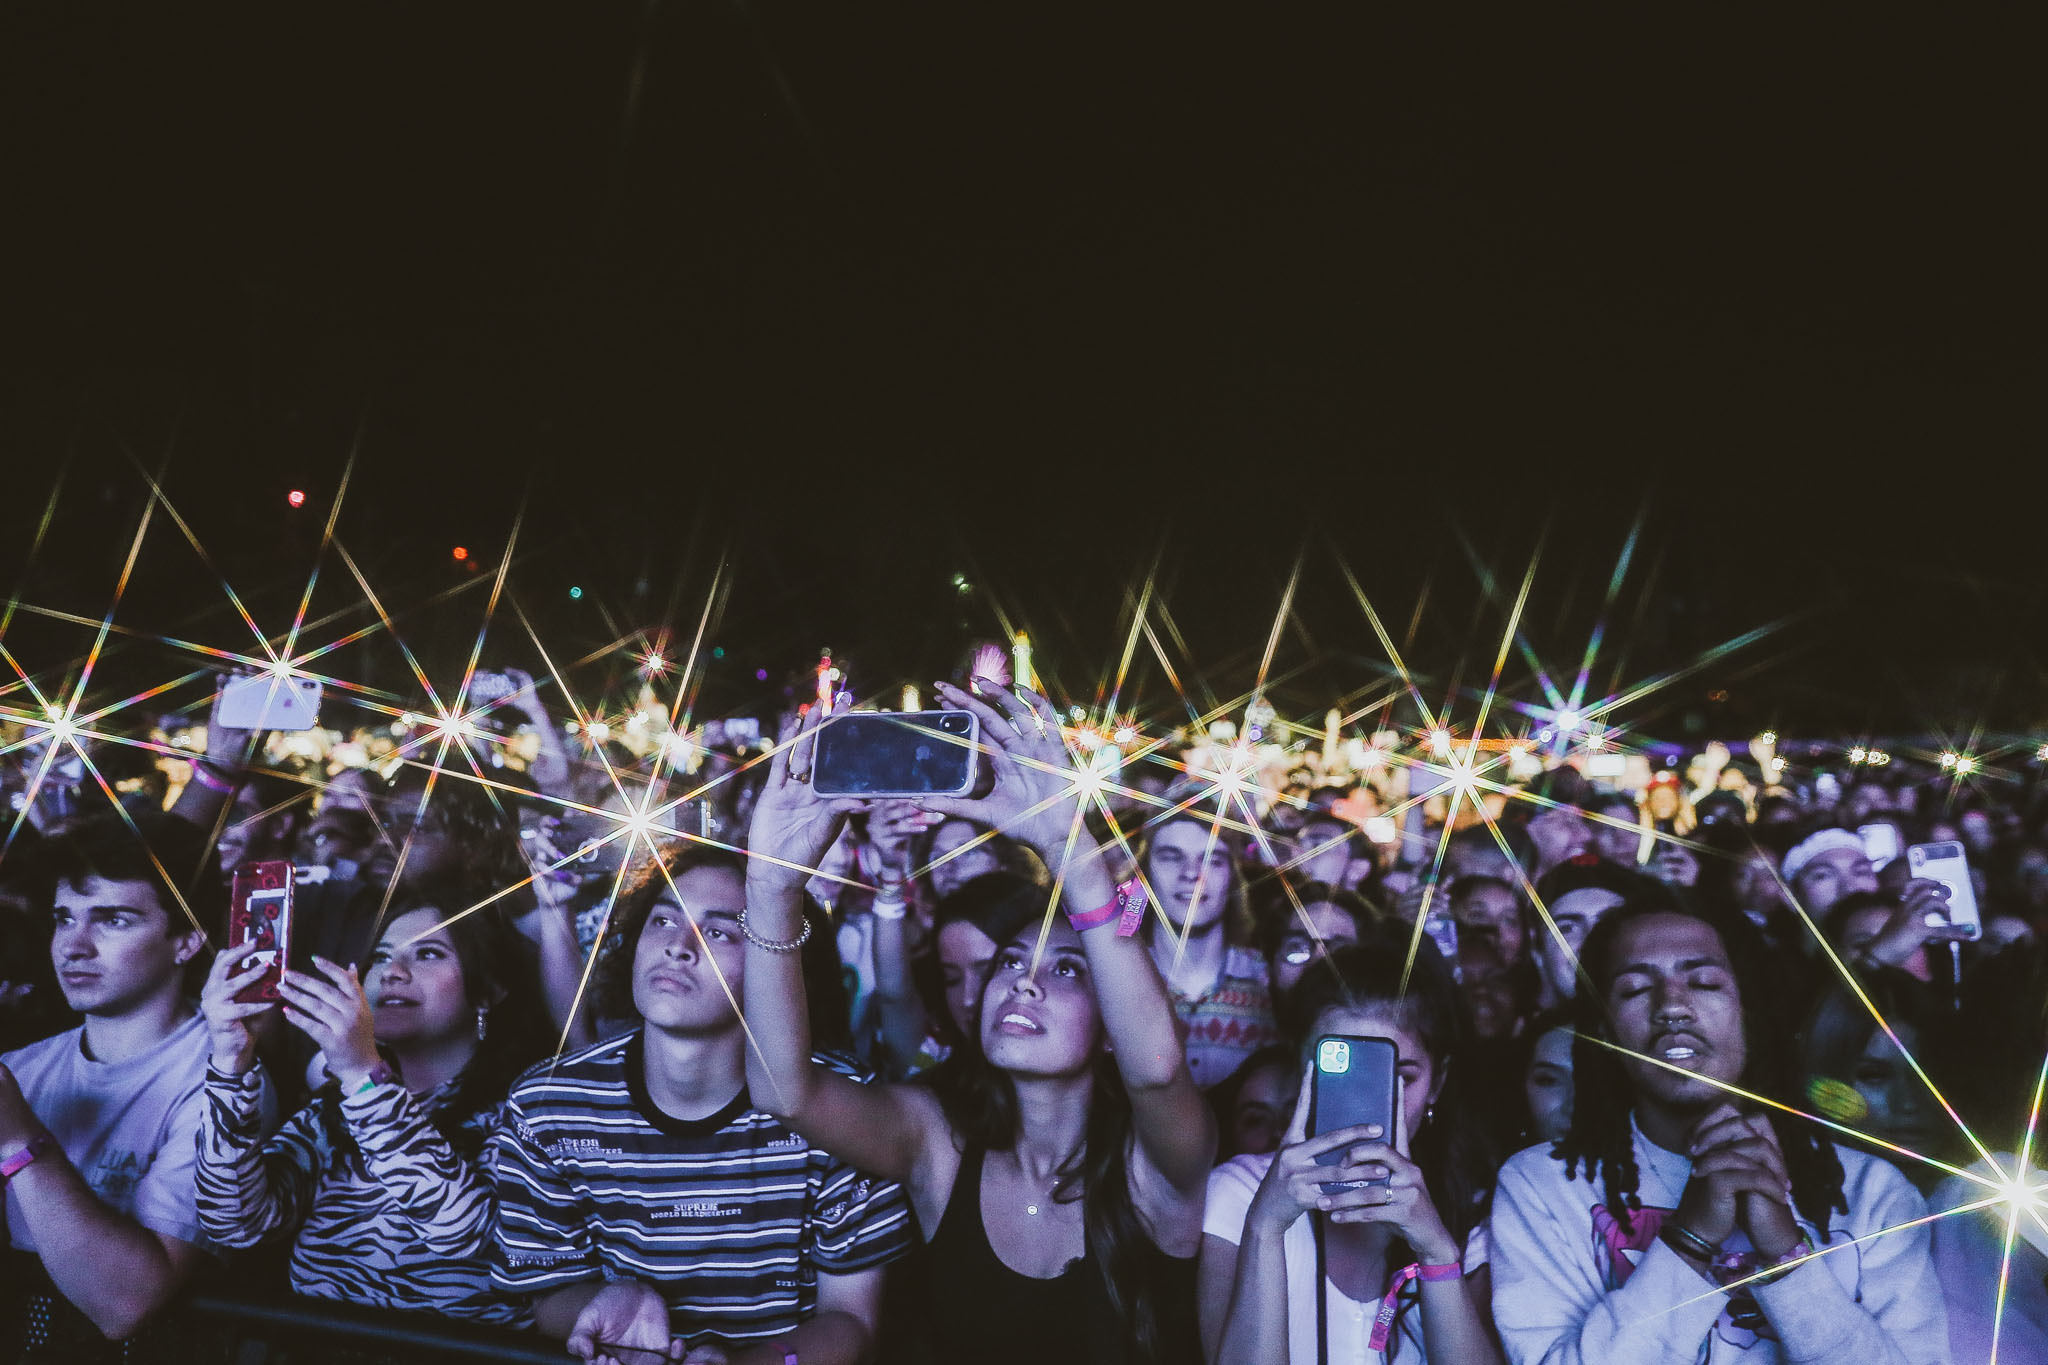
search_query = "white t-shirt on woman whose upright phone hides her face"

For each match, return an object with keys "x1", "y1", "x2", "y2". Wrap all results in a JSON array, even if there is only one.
[{"x1": 1202, "y1": 1156, "x2": 1487, "y2": 1365}]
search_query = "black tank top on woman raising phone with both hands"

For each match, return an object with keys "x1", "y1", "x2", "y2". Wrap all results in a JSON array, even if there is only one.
[{"x1": 911, "y1": 1146, "x2": 1200, "y2": 1365}]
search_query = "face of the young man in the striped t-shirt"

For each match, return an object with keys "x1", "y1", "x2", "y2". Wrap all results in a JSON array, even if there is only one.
[{"x1": 633, "y1": 868, "x2": 748, "y2": 1033}]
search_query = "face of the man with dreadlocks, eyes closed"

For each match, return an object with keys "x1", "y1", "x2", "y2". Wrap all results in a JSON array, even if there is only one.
[{"x1": 1608, "y1": 915, "x2": 1749, "y2": 1109}]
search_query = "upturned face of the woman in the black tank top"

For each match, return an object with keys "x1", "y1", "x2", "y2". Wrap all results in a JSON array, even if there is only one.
[{"x1": 981, "y1": 921, "x2": 1102, "y2": 1076}]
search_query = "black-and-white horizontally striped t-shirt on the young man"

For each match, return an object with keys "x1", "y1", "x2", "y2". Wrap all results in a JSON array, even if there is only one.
[{"x1": 492, "y1": 1029, "x2": 915, "y2": 1345}]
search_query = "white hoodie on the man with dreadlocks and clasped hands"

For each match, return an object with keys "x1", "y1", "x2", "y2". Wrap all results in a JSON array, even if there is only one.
[{"x1": 1491, "y1": 1130, "x2": 1950, "y2": 1365}]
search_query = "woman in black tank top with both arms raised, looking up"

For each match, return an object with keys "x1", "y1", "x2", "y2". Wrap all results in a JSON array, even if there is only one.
[{"x1": 741, "y1": 684, "x2": 1214, "y2": 1365}]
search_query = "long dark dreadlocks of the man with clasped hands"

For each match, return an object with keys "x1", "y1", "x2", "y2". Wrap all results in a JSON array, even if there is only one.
[{"x1": 1552, "y1": 898, "x2": 1849, "y2": 1242}]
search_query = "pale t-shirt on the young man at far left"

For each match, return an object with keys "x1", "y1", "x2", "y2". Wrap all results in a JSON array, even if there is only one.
[{"x1": 0, "y1": 1013, "x2": 207, "y2": 1250}]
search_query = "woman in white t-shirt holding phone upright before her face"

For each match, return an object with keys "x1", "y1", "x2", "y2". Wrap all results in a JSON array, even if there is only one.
[{"x1": 1200, "y1": 931, "x2": 1501, "y2": 1365}]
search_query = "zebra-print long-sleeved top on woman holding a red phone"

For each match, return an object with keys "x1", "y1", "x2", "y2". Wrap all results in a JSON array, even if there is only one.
[{"x1": 197, "y1": 1066, "x2": 530, "y2": 1326}]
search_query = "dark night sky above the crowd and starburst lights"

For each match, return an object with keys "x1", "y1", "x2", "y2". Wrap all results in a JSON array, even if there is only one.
[{"x1": 0, "y1": 0, "x2": 2048, "y2": 731}]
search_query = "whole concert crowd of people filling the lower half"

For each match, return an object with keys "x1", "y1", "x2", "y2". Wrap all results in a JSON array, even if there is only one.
[{"x1": 0, "y1": 663, "x2": 2048, "y2": 1365}]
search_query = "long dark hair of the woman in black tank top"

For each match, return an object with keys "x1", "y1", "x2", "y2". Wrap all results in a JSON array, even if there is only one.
[{"x1": 934, "y1": 939, "x2": 1161, "y2": 1361}]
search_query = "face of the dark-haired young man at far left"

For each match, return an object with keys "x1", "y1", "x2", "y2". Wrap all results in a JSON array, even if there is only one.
[{"x1": 49, "y1": 876, "x2": 205, "y2": 1017}]
